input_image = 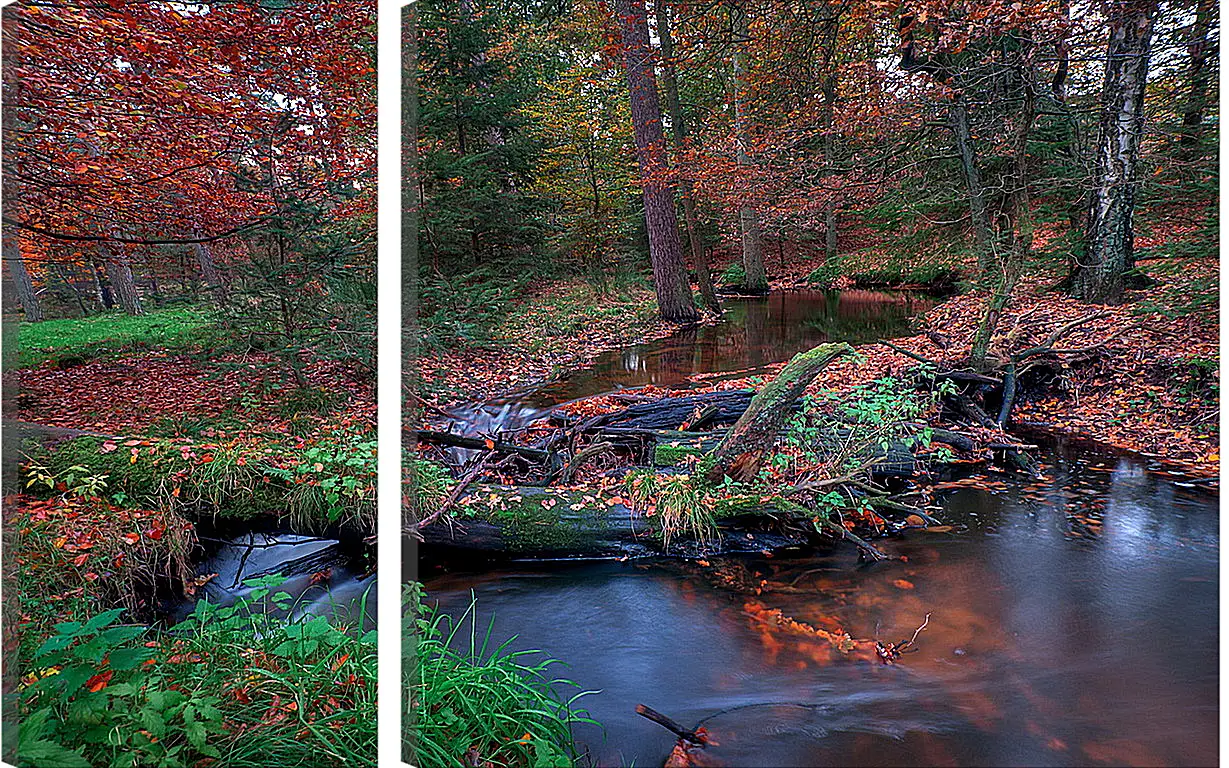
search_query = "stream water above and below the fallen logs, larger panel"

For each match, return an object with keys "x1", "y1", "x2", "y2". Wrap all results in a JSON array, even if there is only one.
[{"x1": 423, "y1": 288, "x2": 1219, "y2": 766}]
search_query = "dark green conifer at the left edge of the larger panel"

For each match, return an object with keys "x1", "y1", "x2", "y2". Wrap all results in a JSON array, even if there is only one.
[{"x1": 418, "y1": 0, "x2": 544, "y2": 268}]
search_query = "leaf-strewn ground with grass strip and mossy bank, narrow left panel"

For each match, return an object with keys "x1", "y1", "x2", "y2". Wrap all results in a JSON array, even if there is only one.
[{"x1": 12, "y1": 310, "x2": 376, "y2": 531}]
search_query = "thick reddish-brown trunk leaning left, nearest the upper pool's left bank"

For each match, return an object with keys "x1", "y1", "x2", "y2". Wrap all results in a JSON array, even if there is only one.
[{"x1": 615, "y1": 0, "x2": 699, "y2": 322}]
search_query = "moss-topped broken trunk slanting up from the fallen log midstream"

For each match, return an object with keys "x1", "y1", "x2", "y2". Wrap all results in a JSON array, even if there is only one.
[{"x1": 704, "y1": 343, "x2": 854, "y2": 484}]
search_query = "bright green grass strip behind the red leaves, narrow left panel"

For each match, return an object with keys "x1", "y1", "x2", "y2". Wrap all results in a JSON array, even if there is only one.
[{"x1": 17, "y1": 307, "x2": 211, "y2": 367}]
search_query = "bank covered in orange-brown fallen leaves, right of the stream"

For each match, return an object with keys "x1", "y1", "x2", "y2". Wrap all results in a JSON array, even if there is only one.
[{"x1": 550, "y1": 263, "x2": 1219, "y2": 478}]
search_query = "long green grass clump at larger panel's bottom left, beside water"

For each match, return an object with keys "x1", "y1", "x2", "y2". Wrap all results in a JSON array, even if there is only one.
[{"x1": 404, "y1": 584, "x2": 594, "y2": 768}]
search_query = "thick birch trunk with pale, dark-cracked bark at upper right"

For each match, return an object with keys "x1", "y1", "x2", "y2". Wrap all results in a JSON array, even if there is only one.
[{"x1": 1072, "y1": 0, "x2": 1158, "y2": 304}]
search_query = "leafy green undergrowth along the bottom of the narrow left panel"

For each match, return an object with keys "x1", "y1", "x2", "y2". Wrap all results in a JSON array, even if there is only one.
[{"x1": 6, "y1": 578, "x2": 376, "y2": 768}]
